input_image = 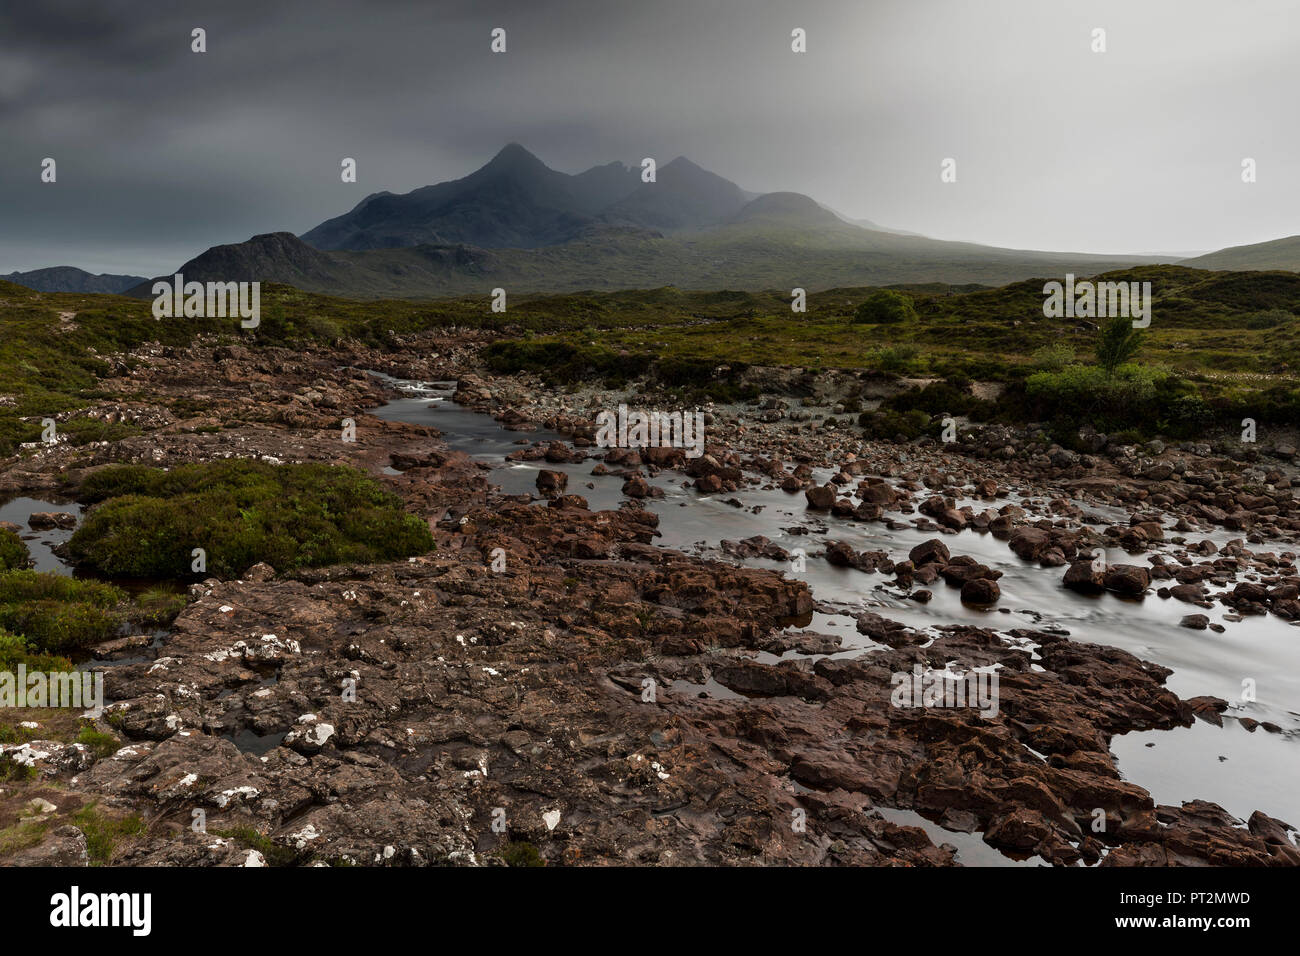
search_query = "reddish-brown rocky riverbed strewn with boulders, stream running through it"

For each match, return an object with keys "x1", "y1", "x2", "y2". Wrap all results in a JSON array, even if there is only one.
[{"x1": 0, "y1": 333, "x2": 1300, "y2": 865}]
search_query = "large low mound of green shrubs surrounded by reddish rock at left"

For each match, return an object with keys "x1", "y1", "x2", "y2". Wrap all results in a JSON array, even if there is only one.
[{"x1": 68, "y1": 459, "x2": 433, "y2": 579}]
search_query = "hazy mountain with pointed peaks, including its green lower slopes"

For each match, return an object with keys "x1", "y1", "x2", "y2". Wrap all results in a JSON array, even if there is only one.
[{"x1": 133, "y1": 143, "x2": 1196, "y2": 298}]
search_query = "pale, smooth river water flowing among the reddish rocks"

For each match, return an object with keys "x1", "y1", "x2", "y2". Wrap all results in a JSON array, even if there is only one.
[{"x1": 373, "y1": 381, "x2": 1300, "y2": 848}]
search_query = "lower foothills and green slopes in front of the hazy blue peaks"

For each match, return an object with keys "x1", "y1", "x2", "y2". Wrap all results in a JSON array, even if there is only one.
[{"x1": 133, "y1": 227, "x2": 1170, "y2": 299}]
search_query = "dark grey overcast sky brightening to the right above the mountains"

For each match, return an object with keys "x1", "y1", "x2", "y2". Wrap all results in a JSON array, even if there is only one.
[{"x1": 0, "y1": 0, "x2": 1300, "y2": 276}]
